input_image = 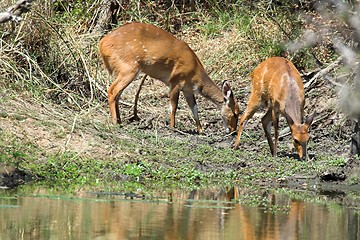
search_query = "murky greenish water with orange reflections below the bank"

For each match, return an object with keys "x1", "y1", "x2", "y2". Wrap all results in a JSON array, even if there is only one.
[{"x1": 0, "y1": 189, "x2": 360, "y2": 240}]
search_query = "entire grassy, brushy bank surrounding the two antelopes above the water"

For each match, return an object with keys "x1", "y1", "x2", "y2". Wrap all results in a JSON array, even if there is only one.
[{"x1": 0, "y1": 0, "x2": 360, "y2": 193}]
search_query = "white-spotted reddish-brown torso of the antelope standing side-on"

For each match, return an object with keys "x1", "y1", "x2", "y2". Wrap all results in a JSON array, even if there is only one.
[{"x1": 99, "y1": 22, "x2": 204, "y2": 84}]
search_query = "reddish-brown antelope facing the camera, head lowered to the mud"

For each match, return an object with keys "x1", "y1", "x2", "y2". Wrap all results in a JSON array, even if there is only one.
[{"x1": 234, "y1": 57, "x2": 315, "y2": 159}]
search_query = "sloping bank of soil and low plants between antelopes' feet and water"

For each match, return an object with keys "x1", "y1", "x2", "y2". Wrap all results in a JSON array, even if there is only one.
[{"x1": 0, "y1": 87, "x2": 360, "y2": 193}]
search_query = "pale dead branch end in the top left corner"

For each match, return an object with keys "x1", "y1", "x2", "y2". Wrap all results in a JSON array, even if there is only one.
[{"x1": 0, "y1": 0, "x2": 32, "y2": 23}]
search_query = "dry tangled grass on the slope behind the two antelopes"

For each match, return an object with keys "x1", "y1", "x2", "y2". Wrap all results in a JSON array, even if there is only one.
[{"x1": 0, "y1": 1, "x2": 350, "y2": 155}]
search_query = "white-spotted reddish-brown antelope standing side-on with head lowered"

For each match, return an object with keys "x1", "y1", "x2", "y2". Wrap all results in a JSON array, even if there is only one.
[{"x1": 99, "y1": 22, "x2": 239, "y2": 133}]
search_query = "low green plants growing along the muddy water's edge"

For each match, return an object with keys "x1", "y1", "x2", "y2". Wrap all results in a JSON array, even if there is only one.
[{"x1": 0, "y1": 114, "x2": 350, "y2": 193}]
